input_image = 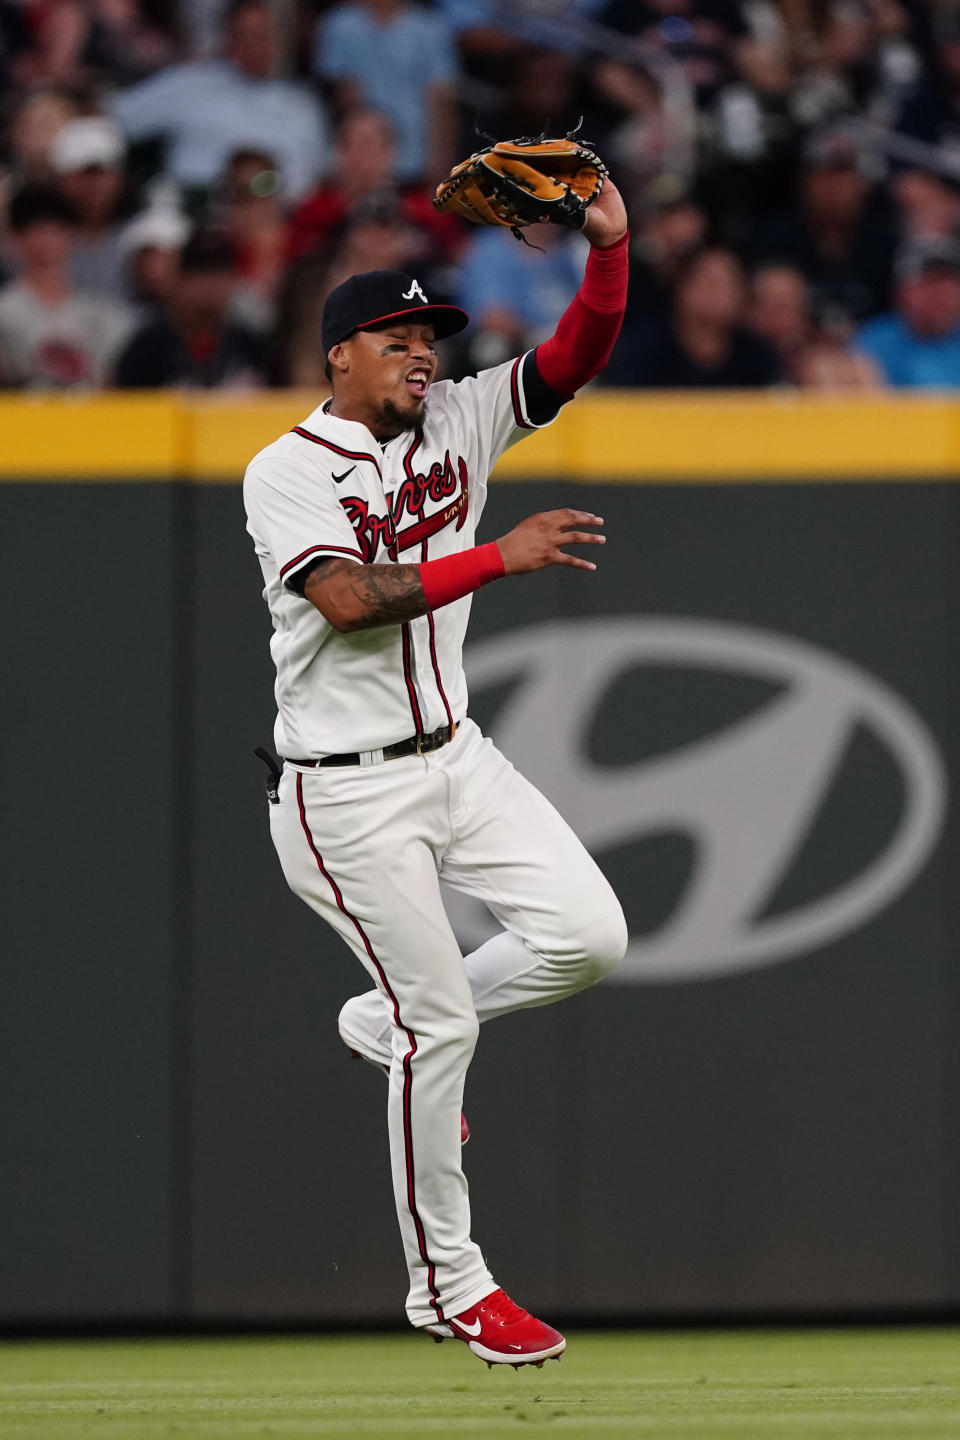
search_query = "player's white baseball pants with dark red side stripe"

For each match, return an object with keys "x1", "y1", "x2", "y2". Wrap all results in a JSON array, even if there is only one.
[{"x1": 269, "y1": 720, "x2": 628, "y2": 1326}]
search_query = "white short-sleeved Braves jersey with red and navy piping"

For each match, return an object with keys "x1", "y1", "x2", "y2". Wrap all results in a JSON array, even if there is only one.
[{"x1": 243, "y1": 356, "x2": 560, "y2": 759}]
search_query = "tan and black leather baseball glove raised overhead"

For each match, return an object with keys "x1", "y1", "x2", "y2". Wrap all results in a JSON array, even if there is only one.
[{"x1": 433, "y1": 131, "x2": 607, "y2": 240}]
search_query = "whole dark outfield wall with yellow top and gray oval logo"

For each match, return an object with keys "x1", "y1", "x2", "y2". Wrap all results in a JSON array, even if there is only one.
[{"x1": 0, "y1": 395, "x2": 960, "y2": 1323}]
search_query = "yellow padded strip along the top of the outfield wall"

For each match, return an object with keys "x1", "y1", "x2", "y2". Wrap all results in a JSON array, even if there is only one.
[{"x1": 0, "y1": 390, "x2": 960, "y2": 484}]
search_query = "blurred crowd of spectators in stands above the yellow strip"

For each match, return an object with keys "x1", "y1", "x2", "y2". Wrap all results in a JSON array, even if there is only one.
[{"x1": 0, "y1": 0, "x2": 960, "y2": 390}]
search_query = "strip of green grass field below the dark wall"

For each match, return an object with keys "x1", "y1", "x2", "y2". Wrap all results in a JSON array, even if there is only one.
[{"x1": 0, "y1": 1328, "x2": 960, "y2": 1440}]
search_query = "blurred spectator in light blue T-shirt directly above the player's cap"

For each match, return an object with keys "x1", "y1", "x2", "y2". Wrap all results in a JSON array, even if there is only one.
[{"x1": 315, "y1": 0, "x2": 456, "y2": 184}]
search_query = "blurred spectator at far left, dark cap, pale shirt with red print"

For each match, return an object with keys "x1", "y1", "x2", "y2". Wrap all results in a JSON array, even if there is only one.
[{"x1": 0, "y1": 184, "x2": 132, "y2": 389}]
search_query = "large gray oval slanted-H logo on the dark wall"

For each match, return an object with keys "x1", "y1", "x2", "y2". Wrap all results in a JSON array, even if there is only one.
[{"x1": 450, "y1": 618, "x2": 947, "y2": 984}]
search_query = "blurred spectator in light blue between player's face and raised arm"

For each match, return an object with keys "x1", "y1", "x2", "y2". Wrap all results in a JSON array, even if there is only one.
[{"x1": 456, "y1": 225, "x2": 586, "y2": 370}]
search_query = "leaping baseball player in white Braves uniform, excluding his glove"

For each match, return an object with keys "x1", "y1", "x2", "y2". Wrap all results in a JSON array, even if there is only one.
[{"x1": 243, "y1": 180, "x2": 628, "y2": 1365}]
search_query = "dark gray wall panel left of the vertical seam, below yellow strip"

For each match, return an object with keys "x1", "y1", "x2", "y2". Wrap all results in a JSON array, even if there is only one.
[{"x1": 0, "y1": 484, "x2": 178, "y2": 1320}]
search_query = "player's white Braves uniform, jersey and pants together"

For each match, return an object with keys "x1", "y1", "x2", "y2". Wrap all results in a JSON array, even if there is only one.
[{"x1": 243, "y1": 356, "x2": 626, "y2": 1326}]
